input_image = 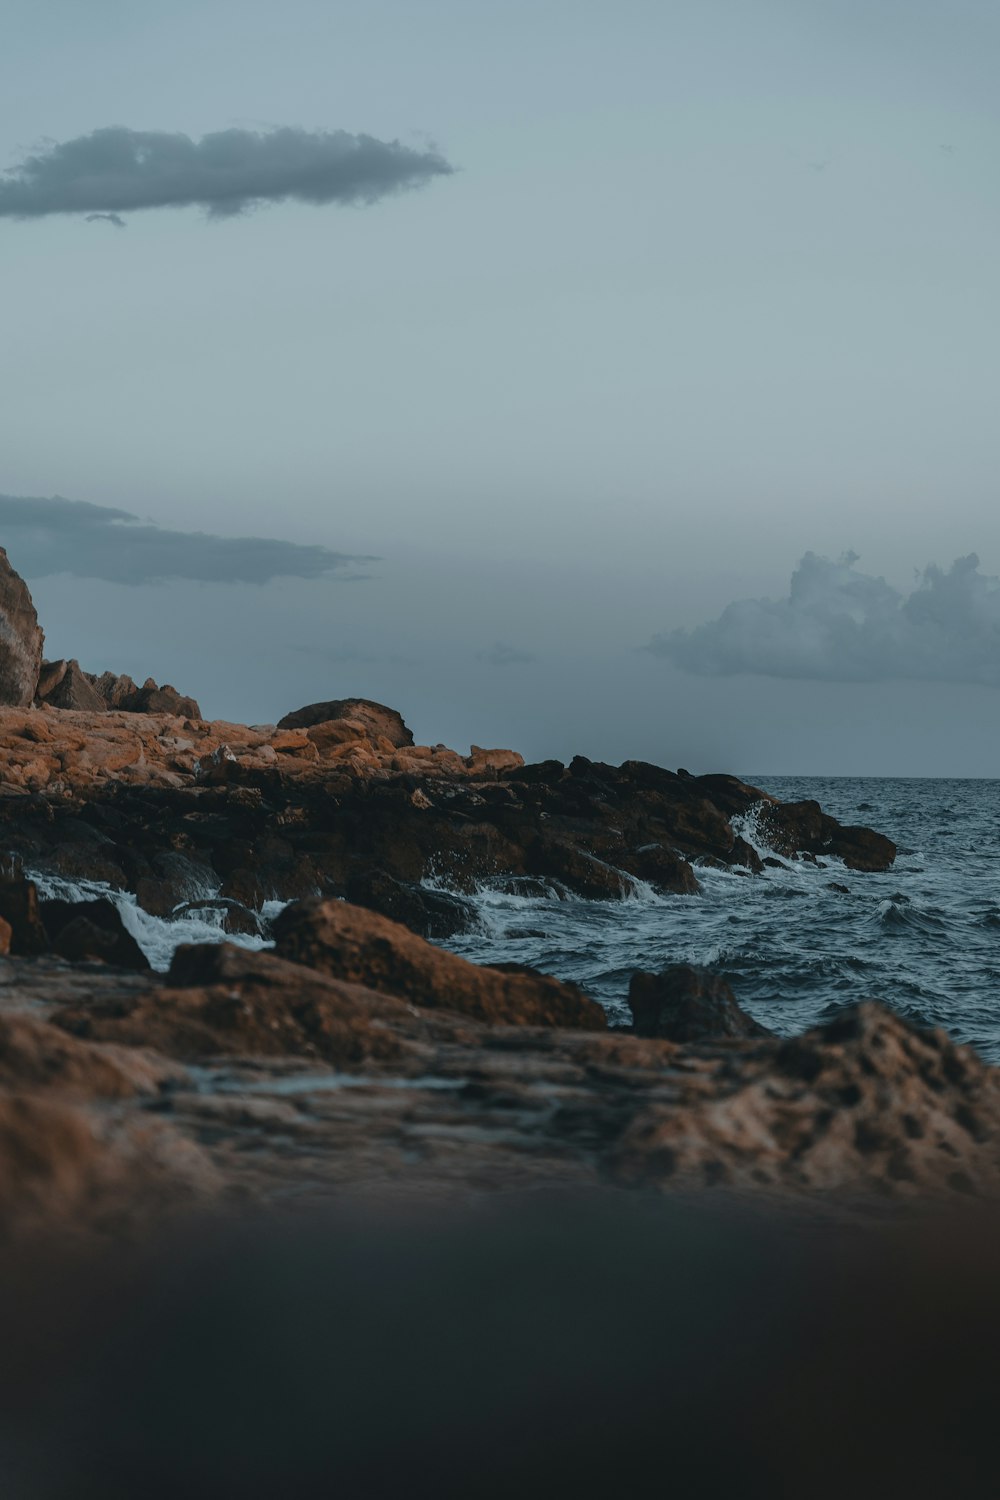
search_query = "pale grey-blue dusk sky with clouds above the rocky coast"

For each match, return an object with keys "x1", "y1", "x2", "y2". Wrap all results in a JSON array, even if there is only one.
[{"x1": 0, "y1": 0, "x2": 1000, "y2": 776}]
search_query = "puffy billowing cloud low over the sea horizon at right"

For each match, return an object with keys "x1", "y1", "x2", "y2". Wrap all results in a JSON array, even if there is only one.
[{"x1": 646, "y1": 552, "x2": 1000, "y2": 687}]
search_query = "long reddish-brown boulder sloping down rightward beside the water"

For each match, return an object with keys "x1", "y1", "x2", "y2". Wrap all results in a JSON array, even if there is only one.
[{"x1": 274, "y1": 900, "x2": 607, "y2": 1031}]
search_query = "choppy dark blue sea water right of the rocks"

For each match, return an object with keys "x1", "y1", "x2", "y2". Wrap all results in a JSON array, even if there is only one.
[{"x1": 448, "y1": 776, "x2": 1000, "y2": 1062}]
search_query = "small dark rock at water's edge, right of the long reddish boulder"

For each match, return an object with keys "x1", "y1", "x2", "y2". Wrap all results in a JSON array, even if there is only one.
[{"x1": 628, "y1": 963, "x2": 771, "y2": 1043}]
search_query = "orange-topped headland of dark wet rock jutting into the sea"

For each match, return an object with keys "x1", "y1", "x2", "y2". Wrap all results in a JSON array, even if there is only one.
[{"x1": 0, "y1": 701, "x2": 895, "y2": 918}]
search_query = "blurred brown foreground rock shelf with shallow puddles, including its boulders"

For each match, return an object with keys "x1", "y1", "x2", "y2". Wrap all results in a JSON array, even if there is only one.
[{"x1": 0, "y1": 903, "x2": 1000, "y2": 1233}]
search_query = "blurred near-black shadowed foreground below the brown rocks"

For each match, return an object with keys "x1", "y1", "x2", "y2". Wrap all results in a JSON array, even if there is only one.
[{"x1": 0, "y1": 1191, "x2": 1000, "y2": 1500}]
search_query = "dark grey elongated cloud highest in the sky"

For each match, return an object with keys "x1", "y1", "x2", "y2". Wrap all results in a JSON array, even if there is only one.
[{"x1": 0, "y1": 125, "x2": 454, "y2": 222}]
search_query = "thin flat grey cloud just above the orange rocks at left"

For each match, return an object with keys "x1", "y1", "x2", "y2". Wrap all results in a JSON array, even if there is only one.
[{"x1": 0, "y1": 495, "x2": 378, "y2": 584}]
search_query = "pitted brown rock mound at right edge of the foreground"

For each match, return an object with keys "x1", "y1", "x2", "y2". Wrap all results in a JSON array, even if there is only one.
[{"x1": 615, "y1": 1001, "x2": 1000, "y2": 1200}]
